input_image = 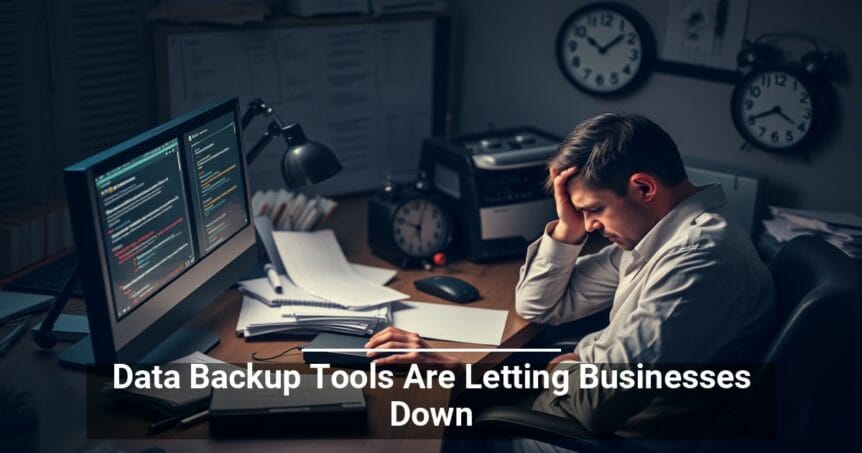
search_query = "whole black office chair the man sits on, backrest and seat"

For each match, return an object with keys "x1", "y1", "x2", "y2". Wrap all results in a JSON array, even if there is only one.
[{"x1": 474, "y1": 236, "x2": 862, "y2": 452}]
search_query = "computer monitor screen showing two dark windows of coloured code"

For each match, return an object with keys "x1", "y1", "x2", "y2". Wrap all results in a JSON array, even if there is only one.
[{"x1": 95, "y1": 112, "x2": 249, "y2": 319}]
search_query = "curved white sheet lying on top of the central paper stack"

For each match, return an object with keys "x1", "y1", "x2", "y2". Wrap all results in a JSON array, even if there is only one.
[{"x1": 273, "y1": 230, "x2": 408, "y2": 308}]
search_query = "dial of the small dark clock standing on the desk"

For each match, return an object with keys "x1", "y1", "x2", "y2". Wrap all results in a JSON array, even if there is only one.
[{"x1": 392, "y1": 198, "x2": 450, "y2": 258}]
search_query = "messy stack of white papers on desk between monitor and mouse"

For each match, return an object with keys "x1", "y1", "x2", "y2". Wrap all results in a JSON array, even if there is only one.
[{"x1": 236, "y1": 230, "x2": 407, "y2": 337}]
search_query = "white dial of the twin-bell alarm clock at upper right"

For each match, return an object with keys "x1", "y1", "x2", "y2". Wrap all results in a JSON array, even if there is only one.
[{"x1": 734, "y1": 70, "x2": 814, "y2": 149}]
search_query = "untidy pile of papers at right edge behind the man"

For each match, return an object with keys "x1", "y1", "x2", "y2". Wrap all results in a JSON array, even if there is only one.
[{"x1": 763, "y1": 206, "x2": 862, "y2": 260}]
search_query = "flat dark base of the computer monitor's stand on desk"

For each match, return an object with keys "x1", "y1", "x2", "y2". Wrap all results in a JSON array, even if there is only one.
[{"x1": 57, "y1": 327, "x2": 219, "y2": 368}]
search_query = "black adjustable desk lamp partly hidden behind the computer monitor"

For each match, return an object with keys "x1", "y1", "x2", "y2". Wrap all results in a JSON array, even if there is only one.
[{"x1": 33, "y1": 98, "x2": 341, "y2": 349}]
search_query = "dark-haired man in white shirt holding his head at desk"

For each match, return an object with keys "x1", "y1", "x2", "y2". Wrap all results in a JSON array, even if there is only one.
[{"x1": 369, "y1": 114, "x2": 775, "y2": 436}]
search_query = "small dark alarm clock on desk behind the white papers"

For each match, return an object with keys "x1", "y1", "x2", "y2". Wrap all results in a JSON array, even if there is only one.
[{"x1": 368, "y1": 177, "x2": 452, "y2": 268}]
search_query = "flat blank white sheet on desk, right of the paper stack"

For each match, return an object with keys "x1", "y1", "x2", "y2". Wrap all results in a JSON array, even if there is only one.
[{"x1": 391, "y1": 302, "x2": 509, "y2": 346}]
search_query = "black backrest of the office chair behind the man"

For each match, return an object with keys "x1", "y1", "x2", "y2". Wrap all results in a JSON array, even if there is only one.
[{"x1": 707, "y1": 236, "x2": 862, "y2": 450}]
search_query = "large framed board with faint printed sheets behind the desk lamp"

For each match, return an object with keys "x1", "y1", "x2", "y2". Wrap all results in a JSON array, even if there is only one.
[{"x1": 155, "y1": 15, "x2": 452, "y2": 195}]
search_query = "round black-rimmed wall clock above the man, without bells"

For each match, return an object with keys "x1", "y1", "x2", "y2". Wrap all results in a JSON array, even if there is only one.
[{"x1": 557, "y1": 3, "x2": 655, "y2": 94}]
